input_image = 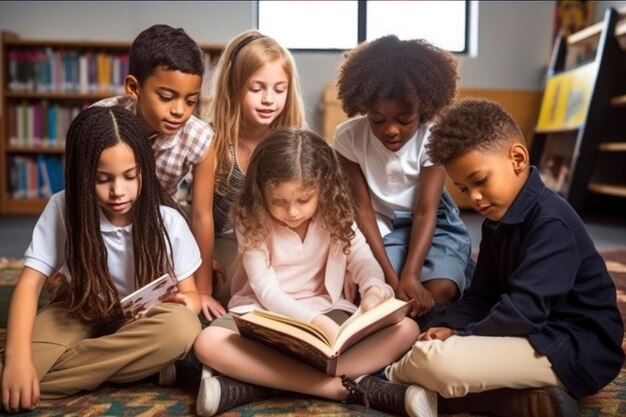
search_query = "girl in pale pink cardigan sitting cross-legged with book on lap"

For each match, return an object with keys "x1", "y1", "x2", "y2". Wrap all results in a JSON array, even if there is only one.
[{"x1": 194, "y1": 129, "x2": 433, "y2": 416}]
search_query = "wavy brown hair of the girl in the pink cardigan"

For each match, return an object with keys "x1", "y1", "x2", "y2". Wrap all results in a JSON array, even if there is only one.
[{"x1": 233, "y1": 128, "x2": 355, "y2": 253}]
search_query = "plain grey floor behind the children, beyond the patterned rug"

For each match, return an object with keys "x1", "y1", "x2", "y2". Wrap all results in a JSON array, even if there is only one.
[{"x1": 0, "y1": 210, "x2": 626, "y2": 258}]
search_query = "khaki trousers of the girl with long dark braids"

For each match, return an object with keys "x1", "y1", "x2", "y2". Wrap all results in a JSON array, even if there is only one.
[{"x1": 0, "y1": 302, "x2": 200, "y2": 399}]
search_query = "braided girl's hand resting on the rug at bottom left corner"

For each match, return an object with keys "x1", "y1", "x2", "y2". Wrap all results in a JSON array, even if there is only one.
[{"x1": 2, "y1": 357, "x2": 39, "y2": 413}]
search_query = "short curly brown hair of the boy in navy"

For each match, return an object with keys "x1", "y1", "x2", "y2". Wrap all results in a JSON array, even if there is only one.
[{"x1": 426, "y1": 98, "x2": 524, "y2": 165}]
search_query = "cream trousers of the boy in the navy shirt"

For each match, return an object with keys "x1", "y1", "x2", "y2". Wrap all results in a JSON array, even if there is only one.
[{"x1": 385, "y1": 336, "x2": 563, "y2": 398}]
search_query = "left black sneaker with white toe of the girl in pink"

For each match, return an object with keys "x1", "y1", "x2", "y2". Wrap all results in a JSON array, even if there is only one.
[{"x1": 196, "y1": 367, "x2": 279, "y2": 416}]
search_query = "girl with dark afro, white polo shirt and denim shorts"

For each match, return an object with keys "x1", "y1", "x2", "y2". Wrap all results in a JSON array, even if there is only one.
[{"x1": 333, "y1": 35, "x2": 473, "y2": 317}]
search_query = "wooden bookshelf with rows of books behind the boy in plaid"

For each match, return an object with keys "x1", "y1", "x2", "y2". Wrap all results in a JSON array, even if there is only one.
[{"x1": 0, "y1": 32, "x2": 223, "y2": 214}]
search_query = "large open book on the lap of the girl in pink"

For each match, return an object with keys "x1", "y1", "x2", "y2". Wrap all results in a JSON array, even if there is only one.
[{"x1": 234, "y1": 298, "x2": 409, "y2": 375}]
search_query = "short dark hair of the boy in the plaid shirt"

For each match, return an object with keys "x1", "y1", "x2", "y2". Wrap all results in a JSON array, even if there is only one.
[{"x1": 128, "y1": 25, "x2": 204, "y2": 84}]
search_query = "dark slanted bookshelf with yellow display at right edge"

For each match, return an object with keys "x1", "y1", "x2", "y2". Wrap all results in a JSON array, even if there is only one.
[{"x1": 530, "y1": 8, "x2": 626, "y2": 211}]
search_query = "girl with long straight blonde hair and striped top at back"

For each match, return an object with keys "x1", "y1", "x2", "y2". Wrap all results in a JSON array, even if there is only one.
[{"x1": 208, "y1": 30, "x2": 305, "y2": 305}]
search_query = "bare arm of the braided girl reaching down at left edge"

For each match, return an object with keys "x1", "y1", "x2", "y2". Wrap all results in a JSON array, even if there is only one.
[{"x1": 2, "y1": 267, "x2": 46, "y2": 412}]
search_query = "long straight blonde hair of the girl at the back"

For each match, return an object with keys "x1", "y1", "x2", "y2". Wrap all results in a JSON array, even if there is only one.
[{"x1": 208, "y1": 30, "x2": 306, "y2": 195}]
